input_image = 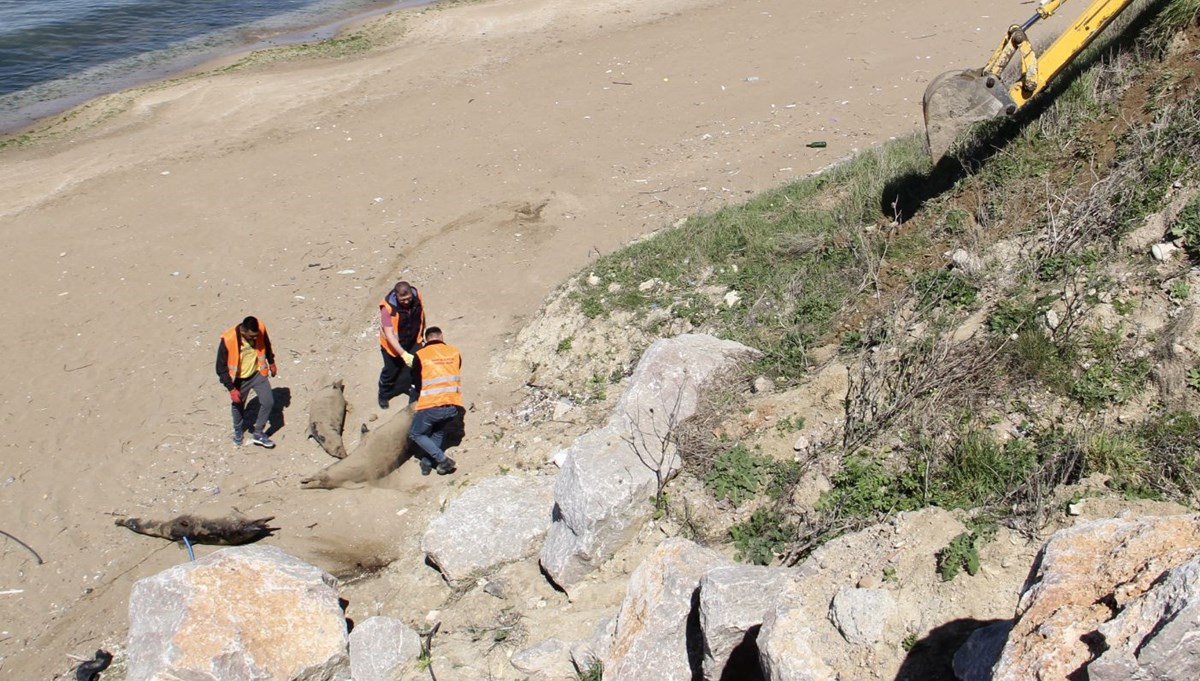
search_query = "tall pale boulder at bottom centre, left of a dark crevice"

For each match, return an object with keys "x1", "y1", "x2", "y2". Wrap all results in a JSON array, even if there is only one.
[{"x1": 604, "y1": 537, "x2": 728, "y2": 681}]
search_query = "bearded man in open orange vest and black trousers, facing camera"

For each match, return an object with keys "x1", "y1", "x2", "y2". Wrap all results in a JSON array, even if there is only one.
[{"x1": 379, "y1": 282, "x2": 425, "y2": 409}]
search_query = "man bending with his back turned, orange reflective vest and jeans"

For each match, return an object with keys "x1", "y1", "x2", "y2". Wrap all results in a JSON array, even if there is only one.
[{"x1": 408, "y1": 326, "x2": 463, "y2": 475}]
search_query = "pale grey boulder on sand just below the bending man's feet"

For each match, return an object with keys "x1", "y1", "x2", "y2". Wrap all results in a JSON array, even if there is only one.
[{"x1": 421, "y1": 475, "x2": 554, "y2": 584}]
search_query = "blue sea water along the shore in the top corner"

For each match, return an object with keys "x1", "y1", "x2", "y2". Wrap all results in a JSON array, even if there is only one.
[{"x1": 0, "y1": 0, "x2": 430, "y2": 132}]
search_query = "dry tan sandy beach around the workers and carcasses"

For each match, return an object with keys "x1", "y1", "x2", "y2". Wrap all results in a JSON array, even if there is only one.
[{"x1": 0, "y1": 0, "x2": 1030, "y2": 680}]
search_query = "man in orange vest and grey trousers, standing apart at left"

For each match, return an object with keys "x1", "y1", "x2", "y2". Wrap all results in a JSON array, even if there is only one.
[{"x1": 216, "y1": 317, "x2": 278, "y2": 450}]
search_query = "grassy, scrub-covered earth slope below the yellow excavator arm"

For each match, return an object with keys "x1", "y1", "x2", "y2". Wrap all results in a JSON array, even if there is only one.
[{"x1": 556, "y1": 0, "x2": 1200, "y2": 563}]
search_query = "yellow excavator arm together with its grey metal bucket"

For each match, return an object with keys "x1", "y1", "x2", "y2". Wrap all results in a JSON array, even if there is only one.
[{"x1": 922, "y1": 0, "x2": 1134, "y2": 163}]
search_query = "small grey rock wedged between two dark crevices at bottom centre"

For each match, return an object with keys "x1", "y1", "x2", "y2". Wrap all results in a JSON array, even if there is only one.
[{"x1": 700, "y1": 565, "x2": 794, "y2": 680}]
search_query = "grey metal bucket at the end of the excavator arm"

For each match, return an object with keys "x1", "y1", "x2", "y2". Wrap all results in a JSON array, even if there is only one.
[{"x1": 922, "y1": 70, "x2": 1016, "y2": 164}]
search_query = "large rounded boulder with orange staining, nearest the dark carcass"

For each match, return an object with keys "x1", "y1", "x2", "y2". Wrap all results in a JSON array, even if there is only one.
[{"x1": 127, "y1": 546, "x2": 350, "y2": 681}]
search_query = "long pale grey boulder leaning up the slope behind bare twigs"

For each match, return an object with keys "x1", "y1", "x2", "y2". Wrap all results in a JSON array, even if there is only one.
[{"x1": 541, "y1": 335, "x2": 758, "y2": 592}]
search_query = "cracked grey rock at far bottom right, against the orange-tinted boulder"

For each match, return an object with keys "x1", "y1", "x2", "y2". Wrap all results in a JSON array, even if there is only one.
[{"x1": 1087, "y1": 559, "x2": 1200, "y2": 681}]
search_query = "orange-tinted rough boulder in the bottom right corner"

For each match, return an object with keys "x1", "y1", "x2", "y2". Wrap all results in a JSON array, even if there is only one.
[{"x1": 992, "y1": 516, "x2": 1200, "y2": 681}]
